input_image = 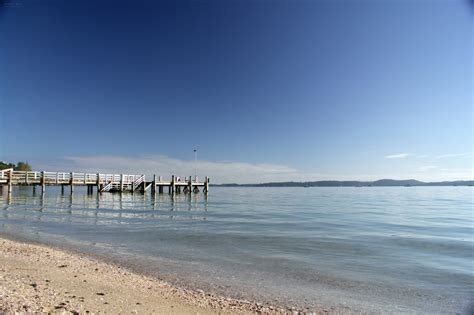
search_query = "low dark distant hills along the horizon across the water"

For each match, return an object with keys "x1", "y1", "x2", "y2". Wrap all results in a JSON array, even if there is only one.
[{"x1": 216, "y1": 179, "x2": 474, "y2": 187}]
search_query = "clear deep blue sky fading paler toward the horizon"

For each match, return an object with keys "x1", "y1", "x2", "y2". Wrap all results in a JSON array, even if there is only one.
[{"x1": 0, "y1": 0, "x2": 474, "y2": 182}]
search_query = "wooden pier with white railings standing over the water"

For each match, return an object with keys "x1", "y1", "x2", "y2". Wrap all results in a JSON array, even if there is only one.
[{"x1": 0, "y1": 169, "x2": 209, "y2": 194}]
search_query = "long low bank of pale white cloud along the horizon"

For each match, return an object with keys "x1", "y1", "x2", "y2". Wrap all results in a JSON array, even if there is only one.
[{"x1": 25, "y1": 155, "x2": 474, "y2": 183}]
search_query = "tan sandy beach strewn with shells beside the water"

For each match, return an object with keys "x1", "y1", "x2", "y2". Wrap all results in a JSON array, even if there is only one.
[{"x1": 0, "y1": 238, "x2": 289, "y2": 314}]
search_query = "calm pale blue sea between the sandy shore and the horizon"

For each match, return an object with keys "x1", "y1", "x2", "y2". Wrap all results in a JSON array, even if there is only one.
[{"x1": 0, "y1": 187, "x2": 474, "y2": 313}]
